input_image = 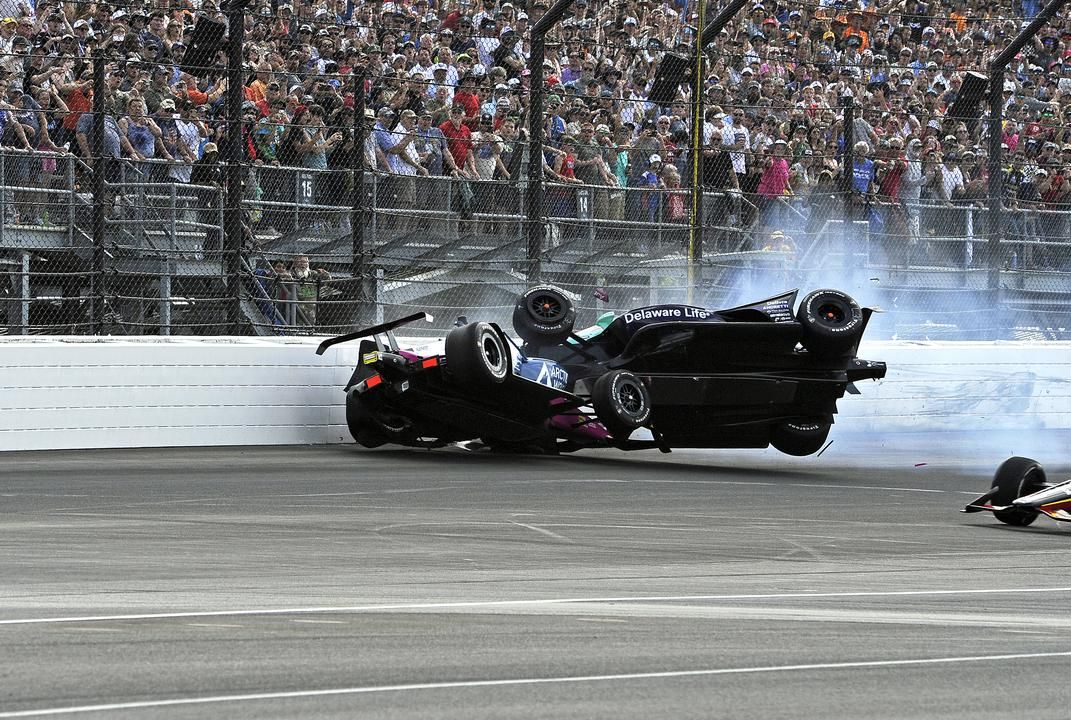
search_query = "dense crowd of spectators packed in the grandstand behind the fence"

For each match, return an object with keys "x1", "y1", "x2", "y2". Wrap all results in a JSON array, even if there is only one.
[{"x1": 0, "y1": 0, "x2": 1071, "y2": 270}]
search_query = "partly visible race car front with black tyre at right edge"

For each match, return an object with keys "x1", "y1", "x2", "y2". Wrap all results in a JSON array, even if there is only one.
[{"x1": 963, "y1": 458, "x2": 1071, "y2": 527}]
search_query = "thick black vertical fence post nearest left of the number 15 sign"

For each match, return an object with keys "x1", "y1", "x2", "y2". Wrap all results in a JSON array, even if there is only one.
[{"x1": 221, "y1": 0, "x2": 247, "y2": 335}]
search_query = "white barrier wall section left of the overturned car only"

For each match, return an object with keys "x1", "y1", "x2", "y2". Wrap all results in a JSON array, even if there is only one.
[{"x1": 0, "y1": 338, "x2": 357, "y2": 450}]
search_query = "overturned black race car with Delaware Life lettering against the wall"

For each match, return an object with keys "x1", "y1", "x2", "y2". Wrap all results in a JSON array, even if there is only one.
[{"x1": 317, "y1": 286, "x2": 886, "y2": 455}]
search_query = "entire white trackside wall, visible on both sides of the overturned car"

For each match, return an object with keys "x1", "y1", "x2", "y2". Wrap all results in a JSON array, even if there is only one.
[{"x1": 0, "y1": 338, "x2": 1071, "y2": 450}]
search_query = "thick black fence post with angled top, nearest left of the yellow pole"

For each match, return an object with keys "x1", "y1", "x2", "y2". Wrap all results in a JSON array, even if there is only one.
[{"x1": 527, "y1": 0, "x2": 573, "y2": 285}]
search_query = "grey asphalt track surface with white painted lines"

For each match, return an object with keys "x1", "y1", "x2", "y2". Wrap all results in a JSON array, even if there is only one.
[{"x1": 0, "y1": 437, "x2": 1071, "y2": 720}]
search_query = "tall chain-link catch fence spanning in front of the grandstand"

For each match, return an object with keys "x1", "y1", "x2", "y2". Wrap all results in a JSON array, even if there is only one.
[{"x1": 0, "y1": 2, "x2": 1071, "y2": 339}]
